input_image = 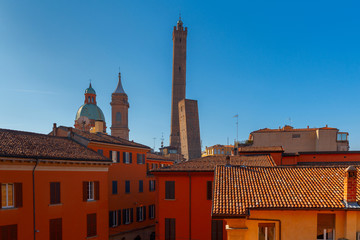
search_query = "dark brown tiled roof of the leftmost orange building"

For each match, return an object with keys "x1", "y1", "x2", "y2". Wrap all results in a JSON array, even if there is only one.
[{"x1": 0, "y1": 129, "x2": 110, "y2": 161}]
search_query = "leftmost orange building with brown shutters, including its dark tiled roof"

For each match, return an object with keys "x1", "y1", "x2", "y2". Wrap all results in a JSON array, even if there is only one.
[{"x1": 0, "y1": 129, "x2": 111, "y2": 240}]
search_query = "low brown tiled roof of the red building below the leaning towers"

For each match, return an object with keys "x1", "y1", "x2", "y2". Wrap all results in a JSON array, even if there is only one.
[{"x1": 152, "y1": 155, "x2": 276, "y2": 172}]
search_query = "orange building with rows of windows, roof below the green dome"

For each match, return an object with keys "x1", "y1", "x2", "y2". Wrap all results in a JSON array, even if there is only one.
[{"x1": 53, "y1": 127, "x2": 172, "y2": 239}]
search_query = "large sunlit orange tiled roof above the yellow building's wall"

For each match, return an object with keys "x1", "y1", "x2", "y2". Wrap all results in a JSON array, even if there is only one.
[{"x1": 212, "y1": 166, "x2": 360, "y2": 217}]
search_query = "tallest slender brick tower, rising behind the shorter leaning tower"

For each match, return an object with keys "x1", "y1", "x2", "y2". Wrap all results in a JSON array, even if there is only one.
[{"x1": 170, "y1": 18, "x2": 187, "y2": 152}]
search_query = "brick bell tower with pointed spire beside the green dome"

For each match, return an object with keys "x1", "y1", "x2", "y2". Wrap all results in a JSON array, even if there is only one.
[{"x1": 110, "y1": 72, "x2": 130, "y2": 140}]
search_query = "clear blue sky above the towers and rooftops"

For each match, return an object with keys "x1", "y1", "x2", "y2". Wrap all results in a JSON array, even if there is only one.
[{"x1": 0, "y1": 0, "x2": 360, "y2": 150}]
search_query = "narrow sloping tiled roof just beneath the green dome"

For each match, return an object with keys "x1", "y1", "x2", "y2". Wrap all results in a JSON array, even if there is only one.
[{"x1": 59, "y1": 126, "x2": 150, "y2": 149}]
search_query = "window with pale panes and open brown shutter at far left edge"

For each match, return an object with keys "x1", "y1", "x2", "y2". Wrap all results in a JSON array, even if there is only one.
[{"x1": 0, "y1": 183, "x2": 22, "y2": 208}]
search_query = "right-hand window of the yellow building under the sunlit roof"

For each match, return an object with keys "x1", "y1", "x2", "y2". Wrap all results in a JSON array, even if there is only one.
[{"x1": 316, "y1": 213, "x2": 335, "y2": 240}]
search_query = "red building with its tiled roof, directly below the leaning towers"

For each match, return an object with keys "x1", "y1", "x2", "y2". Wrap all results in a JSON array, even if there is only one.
[{"x1": 152, "y1": 155, "x2": 274, "y2": 240}]
